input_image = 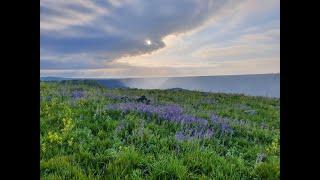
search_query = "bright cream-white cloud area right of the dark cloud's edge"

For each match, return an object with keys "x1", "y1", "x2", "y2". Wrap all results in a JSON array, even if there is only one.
[{"x1": 116, "y1": 0, "x2": 280, "y2": 70}]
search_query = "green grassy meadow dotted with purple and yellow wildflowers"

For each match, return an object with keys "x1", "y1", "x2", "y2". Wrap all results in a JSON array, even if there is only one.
[{"x1": 40, "y1": 81, "x2": 280, "y2": 179}]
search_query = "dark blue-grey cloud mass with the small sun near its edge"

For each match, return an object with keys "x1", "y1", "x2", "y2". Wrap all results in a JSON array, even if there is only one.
[{"x1": 40, "y1": 0, "x2": 239, "y2": 69}]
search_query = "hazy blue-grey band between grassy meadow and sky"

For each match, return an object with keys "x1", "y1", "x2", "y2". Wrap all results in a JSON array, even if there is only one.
[{"x1": 97, "y1": 74, "x2": 280, "y2": 98}]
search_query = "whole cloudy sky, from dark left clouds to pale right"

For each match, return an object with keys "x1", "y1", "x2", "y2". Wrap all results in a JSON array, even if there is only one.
[{"x1": 40, "y1": 0, "x2": 280, "y2": 78}]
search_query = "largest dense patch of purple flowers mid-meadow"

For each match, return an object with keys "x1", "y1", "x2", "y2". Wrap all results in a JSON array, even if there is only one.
[{"x1": 108, "y1": 103, "x2": 233, "y2": 141}]
